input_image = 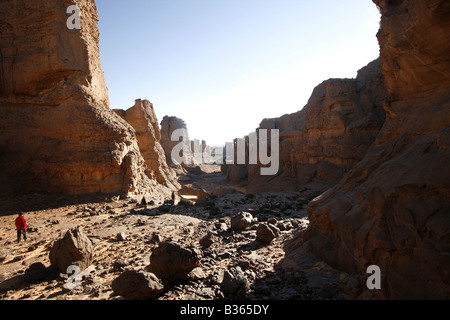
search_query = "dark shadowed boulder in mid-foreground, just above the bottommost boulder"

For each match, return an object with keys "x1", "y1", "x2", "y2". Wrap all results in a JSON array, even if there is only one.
[{"x1": 147, "y1": 242, "x2": 203, "y2": 282}]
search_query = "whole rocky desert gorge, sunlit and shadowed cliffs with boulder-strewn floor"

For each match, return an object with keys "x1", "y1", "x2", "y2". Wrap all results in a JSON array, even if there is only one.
[{"x1": 0, "y1": 0, "x2": 450, "y2": 300}]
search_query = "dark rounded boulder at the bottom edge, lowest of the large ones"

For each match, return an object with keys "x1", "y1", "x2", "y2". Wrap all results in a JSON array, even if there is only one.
[{"x1": 111, "y1": 270, "x2": 164, "y2": 300}]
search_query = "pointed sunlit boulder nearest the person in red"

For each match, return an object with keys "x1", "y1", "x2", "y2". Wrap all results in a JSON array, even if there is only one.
[{"x1": 49, "y1": 227, "x2": 94, "y2": 273}]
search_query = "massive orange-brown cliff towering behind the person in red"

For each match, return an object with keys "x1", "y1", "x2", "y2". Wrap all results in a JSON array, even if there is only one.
[{"x1": 0, "y1": 0, "x2": 161, "y2": 195}]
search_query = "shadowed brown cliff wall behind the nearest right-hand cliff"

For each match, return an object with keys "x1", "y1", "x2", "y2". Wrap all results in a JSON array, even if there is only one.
[{"x1": 226, "y1": 59, "x2": 385, "y2": 193}]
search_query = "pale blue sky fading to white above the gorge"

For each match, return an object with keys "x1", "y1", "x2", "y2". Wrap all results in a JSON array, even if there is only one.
[{"x1": 96, "y1": 0, "x2": 380, "y2": 146}]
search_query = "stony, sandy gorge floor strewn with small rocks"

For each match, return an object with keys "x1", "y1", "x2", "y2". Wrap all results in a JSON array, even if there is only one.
[{"x1": 0, "y1": 165, "x2": 370, "y2": 300}]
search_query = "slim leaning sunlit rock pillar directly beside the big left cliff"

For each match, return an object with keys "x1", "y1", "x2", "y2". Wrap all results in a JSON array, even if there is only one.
[{"x1": 113, "y1": 99, "x2": 180, "y2": 191}]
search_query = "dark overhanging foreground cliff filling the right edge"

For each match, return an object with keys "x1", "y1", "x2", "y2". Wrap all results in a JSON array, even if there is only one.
[{"x1": 296, "y1": 0, "x2": 450, "y2": 299}]
